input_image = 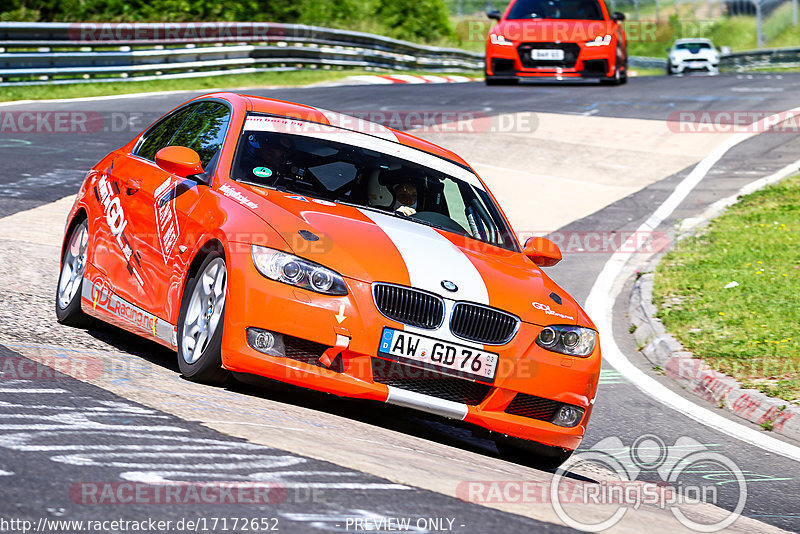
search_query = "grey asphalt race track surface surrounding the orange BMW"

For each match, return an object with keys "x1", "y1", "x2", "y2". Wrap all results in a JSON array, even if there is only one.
[{"x1": 0, "y1": 74, "x2": 800, "y2": 533}]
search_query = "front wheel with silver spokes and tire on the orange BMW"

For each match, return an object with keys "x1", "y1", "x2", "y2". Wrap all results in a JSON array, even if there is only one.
[{"x1": 178, "y1": 252, "x2": 230, "y2": 385}]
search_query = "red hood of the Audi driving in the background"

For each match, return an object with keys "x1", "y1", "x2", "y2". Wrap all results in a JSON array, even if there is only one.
[{"x1": 492, "y1": 19, "x2": 617, "y2": 42}]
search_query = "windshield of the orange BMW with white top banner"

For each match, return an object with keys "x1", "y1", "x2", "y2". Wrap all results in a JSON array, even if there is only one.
[{"x1": 231, "y1": 115, "x2": 519, "y2": 251}]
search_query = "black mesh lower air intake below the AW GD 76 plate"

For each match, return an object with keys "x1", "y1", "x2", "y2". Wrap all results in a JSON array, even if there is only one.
[{"x1": 372, "y1": 358, "x2": 492, "y2": 406}]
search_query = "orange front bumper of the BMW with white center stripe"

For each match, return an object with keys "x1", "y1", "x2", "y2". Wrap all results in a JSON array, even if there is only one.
[{"x1": 222, "y1": 250, "x2": 600, "y2": 450}]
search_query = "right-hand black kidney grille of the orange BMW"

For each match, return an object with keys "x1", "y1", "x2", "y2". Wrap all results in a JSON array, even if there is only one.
[{"x1": 450, "y1": 302, "x2": 519, "y2": 345}]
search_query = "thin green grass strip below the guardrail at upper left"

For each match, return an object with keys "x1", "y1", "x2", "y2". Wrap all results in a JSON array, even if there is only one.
[{"x1": 0, "y1": 69, "x2": 483, "y2": 101}]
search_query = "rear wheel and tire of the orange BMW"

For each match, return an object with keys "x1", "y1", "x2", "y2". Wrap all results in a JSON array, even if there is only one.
[{"x1": 56, "y1": 219, "x2": 94, "y2": 328}]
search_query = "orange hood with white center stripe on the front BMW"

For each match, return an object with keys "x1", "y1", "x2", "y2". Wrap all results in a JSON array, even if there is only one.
[{"x1": 244, "y1": 188, "x2": 593, "y2": 327}]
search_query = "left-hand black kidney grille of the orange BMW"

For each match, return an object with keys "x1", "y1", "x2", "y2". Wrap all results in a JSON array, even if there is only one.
[{"x1": 373, "y1": 284, "x2": 444, "y2": 330}]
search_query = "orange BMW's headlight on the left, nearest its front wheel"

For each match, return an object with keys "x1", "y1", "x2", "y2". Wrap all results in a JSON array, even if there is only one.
[{"x1": 250, "y1": 245, "x2": 347, "y2": 295}]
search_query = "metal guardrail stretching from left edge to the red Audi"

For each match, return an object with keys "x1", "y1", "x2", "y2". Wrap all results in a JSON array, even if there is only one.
[{"x1": 0, "y1": 22, "x2": 483, "y2": 85}]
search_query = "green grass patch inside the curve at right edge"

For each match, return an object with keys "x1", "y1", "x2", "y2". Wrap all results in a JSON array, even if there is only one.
[{"x1": 654, "y1": 174, "x2": 800, "y2": 402}]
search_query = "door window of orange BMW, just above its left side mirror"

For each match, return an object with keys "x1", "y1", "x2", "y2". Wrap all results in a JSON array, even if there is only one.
[{"x1": 170, "y1": 102, "x2": 231, "y2": 167}]
